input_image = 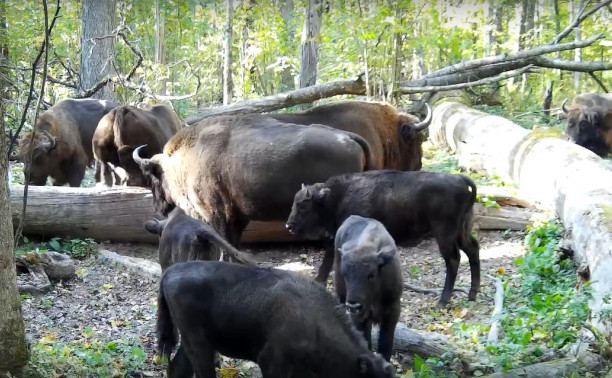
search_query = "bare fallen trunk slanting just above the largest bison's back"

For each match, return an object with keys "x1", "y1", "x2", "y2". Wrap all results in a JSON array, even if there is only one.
[{"x1": 185, "y1": 75, "x2": 365, "y2": 125}]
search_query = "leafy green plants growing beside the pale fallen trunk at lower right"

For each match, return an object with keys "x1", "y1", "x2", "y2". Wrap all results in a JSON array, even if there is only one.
[{"x1": 488, "y1": 220, "x2": 590, "y2": 370}]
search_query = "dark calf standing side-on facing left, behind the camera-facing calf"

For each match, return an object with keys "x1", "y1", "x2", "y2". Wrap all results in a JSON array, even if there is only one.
[{"x1": 287, "y1": 170, "x2": 480, "y2": 307}]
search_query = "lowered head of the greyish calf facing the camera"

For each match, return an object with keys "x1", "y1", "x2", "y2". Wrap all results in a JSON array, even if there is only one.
[{"x1": 336, "y1": 243, "x2": 396, "y2": 321}]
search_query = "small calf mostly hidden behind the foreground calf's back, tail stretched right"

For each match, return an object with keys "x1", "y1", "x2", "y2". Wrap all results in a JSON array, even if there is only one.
[{"x1": 144, "y1": 207, "x2": 257, "y2": 272}]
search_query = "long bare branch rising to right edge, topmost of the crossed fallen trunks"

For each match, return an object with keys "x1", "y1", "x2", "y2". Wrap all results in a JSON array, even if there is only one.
[{"x1": 422, "y1": 34, "x2": 612, "y2": 79}]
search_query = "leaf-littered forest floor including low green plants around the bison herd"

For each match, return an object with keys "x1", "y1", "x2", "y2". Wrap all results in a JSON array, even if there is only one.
[{"x1": 13, "y1": 142, "x2": 604, "y2": 378}]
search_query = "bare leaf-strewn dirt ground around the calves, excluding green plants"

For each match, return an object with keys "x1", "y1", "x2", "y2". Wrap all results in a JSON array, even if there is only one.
[{"x1": 23, "y1": 231, "x2": 524, "y2": 377}]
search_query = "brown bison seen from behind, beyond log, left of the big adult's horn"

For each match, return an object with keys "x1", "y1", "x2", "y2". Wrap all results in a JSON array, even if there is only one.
[{"x1": 92, "y1": 105, "x2": 182, "y2": 186}]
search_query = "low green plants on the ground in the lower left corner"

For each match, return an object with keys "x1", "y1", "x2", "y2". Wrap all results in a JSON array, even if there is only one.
[{"x1": 30, "y1": 336, "x2": 147, "y2": 377}]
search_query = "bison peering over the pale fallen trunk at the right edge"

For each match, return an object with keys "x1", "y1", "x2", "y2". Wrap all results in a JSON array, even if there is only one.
[{"x1": 561, "y1": 93, "x2": 612, "y2": 157}]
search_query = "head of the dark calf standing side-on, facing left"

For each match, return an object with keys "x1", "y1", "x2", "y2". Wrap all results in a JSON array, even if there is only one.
[{"x1": 285, "y1": 183, "x2": 333, "y2": 240}]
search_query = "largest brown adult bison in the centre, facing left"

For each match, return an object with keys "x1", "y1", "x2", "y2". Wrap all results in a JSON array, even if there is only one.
[{"x1": 133, "y1": 115, "x2": 371, "y2": 246}]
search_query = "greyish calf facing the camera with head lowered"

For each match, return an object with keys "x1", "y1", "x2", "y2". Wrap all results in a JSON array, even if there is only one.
[{"x1": 335, "y1": 215, "x2": 403, "y2": 361}]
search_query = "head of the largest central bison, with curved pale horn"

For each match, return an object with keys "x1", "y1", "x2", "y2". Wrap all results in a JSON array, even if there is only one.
[{"x1": 132, "y1": 145, "x2": 175, "y2": 216}]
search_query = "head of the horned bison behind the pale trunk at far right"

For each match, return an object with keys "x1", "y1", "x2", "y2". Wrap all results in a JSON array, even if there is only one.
[{"x1": 561, "y1": 99, "x2": 612, "y2": 157}]
